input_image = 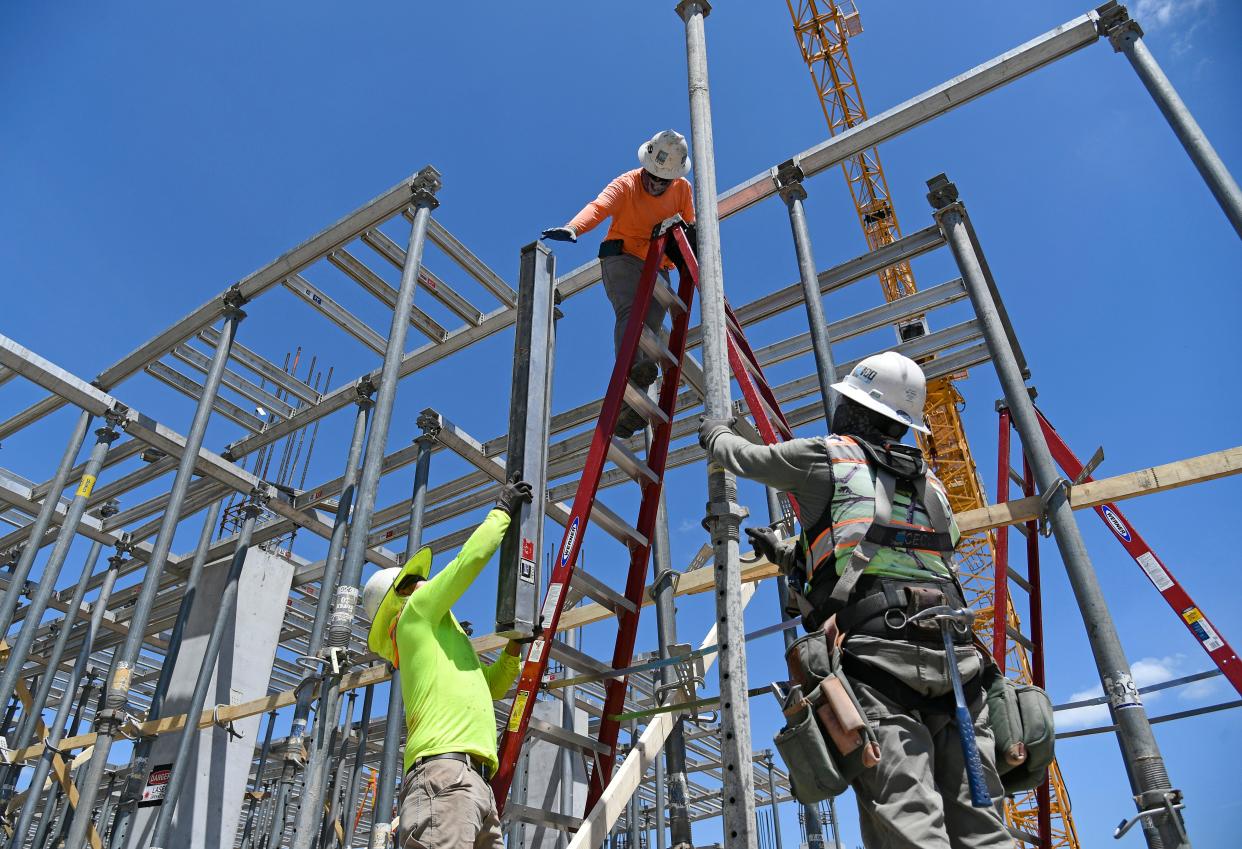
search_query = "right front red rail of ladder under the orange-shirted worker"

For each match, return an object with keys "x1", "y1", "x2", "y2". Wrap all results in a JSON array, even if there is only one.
[{"x1": 585, "y1": 248, "x2": 698, "y2": 811}]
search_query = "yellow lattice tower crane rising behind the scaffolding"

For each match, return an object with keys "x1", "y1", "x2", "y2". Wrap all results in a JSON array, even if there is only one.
[{"x1": 785, "y1": 0, "x2": 1078, "y2": 849}]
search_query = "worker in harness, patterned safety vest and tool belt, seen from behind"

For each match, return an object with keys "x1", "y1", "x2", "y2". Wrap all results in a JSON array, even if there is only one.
[{"x1": 699, "y1": 351, "x2": 1013, "y2": 849}]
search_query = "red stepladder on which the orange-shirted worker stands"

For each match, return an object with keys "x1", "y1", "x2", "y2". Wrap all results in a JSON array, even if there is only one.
[{"x1": 492, "y1": 216, "x2": 792, "y2": 811}]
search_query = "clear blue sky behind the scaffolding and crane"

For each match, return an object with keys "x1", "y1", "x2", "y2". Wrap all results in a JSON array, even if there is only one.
[{"x1": 0, "y1": 0, "x2": 1242, "y2": 845}]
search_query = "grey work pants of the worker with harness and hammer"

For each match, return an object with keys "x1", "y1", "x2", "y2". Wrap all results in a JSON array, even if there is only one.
[{"x1": 846, "y1": 634, "x2": 1013, "y2": 849}]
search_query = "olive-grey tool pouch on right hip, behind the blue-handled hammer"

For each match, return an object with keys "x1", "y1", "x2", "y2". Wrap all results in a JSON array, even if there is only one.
[{"x1": 984, "y1": 665, "x2": 1056, "y2": 793}]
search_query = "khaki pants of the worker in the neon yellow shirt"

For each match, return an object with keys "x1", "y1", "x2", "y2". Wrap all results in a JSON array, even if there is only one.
[{"x1": 397, "y1": 758, "x2": 504, "y2": 849}]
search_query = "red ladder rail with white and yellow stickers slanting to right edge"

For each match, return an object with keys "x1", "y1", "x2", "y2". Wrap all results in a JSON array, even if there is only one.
[{"x1": 1035, "y1": 407, "x2": 1242, "y2": 695}]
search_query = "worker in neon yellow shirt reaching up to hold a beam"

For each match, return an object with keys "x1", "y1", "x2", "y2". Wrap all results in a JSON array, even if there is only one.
[{"x1": 363, "y1": 475, "x2": 532, "y2": 849}]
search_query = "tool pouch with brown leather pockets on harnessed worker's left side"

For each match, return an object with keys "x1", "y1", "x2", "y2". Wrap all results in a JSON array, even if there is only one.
[{"x1": 773, "y1": 620, "x2": 879, "y2": 804}]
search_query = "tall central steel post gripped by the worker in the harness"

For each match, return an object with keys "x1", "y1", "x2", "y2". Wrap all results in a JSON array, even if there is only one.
[{"x1": 677, "y1": 0, "x2": 755, "y2": 849}]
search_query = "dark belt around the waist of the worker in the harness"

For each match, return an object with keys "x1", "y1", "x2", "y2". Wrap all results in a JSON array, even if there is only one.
[{"x1": 836, "y1": 577, "x2": 971, "y2": 645}]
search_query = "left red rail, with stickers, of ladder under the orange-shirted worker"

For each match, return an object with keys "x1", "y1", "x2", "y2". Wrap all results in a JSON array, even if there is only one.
[{"x1": 492, "y1": 236, "x2": 667, "y2": 812}]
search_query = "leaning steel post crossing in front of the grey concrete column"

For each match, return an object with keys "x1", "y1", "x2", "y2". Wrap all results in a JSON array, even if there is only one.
[{"x1": 150, "y1": 492, "x2": 267, "y2": 849}]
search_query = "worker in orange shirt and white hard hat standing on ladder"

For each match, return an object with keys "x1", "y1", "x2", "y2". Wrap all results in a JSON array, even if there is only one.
[{"x1": 543, "y1": 129, "x2": 694, "y2": 437}]
